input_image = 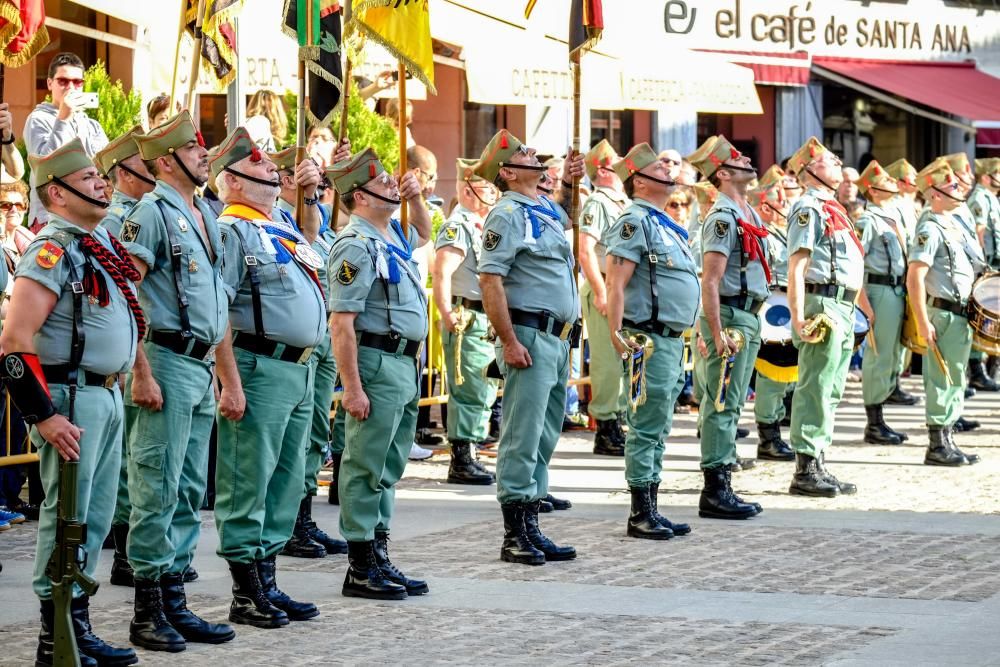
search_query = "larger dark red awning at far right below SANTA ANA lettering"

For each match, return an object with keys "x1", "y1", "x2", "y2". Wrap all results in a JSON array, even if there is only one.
[{"x1": 813, "y1": 58, "x2": 1000, "y2": 131}]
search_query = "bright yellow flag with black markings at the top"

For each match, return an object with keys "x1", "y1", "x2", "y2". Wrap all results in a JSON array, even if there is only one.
[{"x1": 347, "y1": 0, "x2": 437, "y2": 95}]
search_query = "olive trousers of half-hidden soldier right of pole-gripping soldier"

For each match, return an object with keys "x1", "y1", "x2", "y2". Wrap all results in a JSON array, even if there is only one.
[{"x1": 580, "y1": 282, "x2": 628, "y2": 421}]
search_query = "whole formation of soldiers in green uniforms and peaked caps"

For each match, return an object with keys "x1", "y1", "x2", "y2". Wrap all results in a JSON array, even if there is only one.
[{"x1": 0, "y1": 102, "x2": 998, "y2": 665}]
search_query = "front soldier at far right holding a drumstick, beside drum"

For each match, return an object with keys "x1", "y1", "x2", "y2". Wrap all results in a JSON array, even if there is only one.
[{"x1": 906, "y1": 159, "x2": 979, "y2": 466}]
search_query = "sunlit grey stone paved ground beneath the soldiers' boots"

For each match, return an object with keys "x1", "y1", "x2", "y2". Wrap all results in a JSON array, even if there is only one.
[{"x1": 0, "y1": 383, "x2": 1000, "y2": 667}]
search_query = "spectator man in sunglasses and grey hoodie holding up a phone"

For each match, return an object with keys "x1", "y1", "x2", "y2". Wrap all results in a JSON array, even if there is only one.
[{"x1": 24, "y1": 53, "x2": 108, "y2": 232}]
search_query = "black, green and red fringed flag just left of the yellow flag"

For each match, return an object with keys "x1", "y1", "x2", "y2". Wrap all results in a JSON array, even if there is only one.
[{"x1": 282, "y1": 0, "x2": 344, "y2": 127}]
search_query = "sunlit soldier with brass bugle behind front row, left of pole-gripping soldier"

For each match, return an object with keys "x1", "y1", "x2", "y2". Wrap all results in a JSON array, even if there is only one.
[{"x1": 432, "y1": 158, "x2": 498, "y2": 484}]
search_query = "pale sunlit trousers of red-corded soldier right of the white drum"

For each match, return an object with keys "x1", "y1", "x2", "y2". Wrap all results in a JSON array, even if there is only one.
[{"x1": 789, "y1": 294, "x2": 854, "y2": 458}]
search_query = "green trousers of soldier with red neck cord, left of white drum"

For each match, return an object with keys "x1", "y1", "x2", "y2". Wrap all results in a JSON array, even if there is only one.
[{"x1": 700, "y1": 305, "x2": 760, "y2": 470}]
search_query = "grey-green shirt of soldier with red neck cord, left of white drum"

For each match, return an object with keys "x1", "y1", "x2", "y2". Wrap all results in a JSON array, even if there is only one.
[{"x1": 701, "y1": 192, "x2": 770, "y2": 301}]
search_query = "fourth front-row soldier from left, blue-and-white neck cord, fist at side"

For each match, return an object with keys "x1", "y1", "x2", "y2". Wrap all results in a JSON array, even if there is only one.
[{"x1": 329, "y1": 148, "x2": 430, "y2": 600}]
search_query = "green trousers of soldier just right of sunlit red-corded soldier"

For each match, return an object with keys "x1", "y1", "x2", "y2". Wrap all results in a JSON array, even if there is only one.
[{"x1": 861, "y1": 285, "x2": 906, "y2": 405}]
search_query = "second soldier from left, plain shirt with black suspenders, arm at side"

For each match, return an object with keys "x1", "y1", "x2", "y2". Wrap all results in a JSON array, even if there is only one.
[{"x1": 121, "y1": 111, "x2": 235, "y2": 651}]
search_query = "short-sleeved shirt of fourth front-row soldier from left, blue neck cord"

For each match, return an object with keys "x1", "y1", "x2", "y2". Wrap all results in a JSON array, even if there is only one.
[{"x1": 329, "y1": 215, "x2": 427, "y2": 340}]
